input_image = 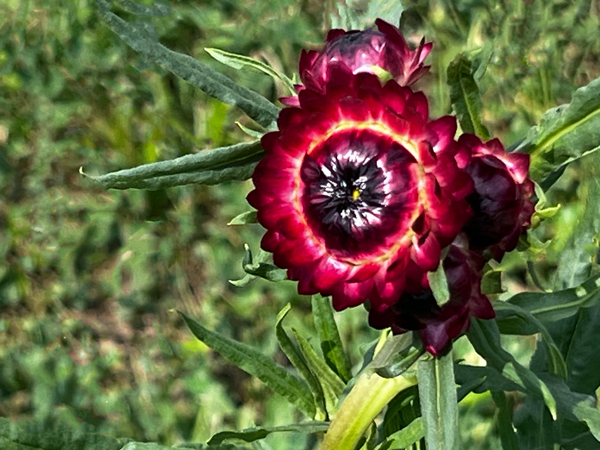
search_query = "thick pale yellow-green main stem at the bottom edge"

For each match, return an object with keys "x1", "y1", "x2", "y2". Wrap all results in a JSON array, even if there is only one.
[{"x1": 319, "y1": 373, "x2": 417, "y2": 450}]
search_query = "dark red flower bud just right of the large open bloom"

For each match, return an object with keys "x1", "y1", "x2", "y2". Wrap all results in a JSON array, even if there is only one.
[{"x1": 456, "y1": 134, "x2": 534, "y2": 261}]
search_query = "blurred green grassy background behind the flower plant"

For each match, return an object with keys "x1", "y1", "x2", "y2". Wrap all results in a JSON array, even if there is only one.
[{"x1": 0, "y1": 0, "x2": 600, "y2": 449}]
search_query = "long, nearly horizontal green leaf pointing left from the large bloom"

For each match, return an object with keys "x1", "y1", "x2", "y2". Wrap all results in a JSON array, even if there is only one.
[{"x1": 81, "y1": 141, "x2": 264, "y2": 190}]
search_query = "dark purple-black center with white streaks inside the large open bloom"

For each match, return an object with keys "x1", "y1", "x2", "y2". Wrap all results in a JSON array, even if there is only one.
[{"x1": 300, "y1": 130, "x2": 417, "y2": 252}]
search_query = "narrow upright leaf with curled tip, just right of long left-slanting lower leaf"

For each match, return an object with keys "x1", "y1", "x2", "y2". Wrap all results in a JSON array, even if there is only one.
[{"x1": 275, "y1": 303, "x2": 327, "y2": 418}]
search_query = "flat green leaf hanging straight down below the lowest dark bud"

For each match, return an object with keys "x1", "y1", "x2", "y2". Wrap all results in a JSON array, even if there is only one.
[{"x1": 417, "y1": 352, "x2": 458, "y2": 450}]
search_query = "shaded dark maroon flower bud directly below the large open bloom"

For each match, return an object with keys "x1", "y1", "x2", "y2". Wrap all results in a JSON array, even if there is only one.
[{"x1": 369, "y1": 235, "x2": 495, "y2": 355}]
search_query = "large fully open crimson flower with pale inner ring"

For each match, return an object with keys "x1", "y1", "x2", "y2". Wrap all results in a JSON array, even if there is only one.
[{"x1": 248, "y1": 65, "x2": 472, "y2": 310}]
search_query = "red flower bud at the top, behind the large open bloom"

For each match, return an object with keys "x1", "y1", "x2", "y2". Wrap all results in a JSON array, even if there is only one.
[{"x1": 281, "y1": 19, "x2": 432, "y2": 106}]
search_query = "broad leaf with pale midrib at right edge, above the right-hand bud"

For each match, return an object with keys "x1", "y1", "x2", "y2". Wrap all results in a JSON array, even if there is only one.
[{"x1": 516, "y1": 78, "x2": 600, "y2": 185}]
